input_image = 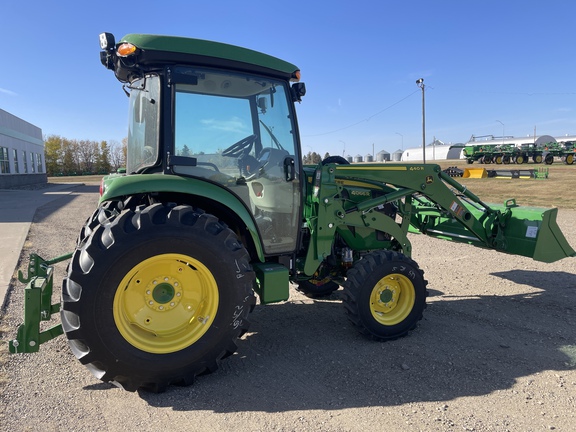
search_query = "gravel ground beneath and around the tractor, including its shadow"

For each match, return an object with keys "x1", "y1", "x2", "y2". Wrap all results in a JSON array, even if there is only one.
[{"x1": 0, "y1": 185, "x2": 576, "y2": 432}]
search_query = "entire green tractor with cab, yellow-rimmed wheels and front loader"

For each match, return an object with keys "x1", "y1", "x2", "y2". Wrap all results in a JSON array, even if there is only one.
[{"x1": 10, "y1": 33, "x2": 576, "y2": 391}]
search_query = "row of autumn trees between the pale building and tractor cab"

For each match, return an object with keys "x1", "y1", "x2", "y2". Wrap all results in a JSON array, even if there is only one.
[{"x1": 44, "y1": 135, "x2": 127, "y2": 177}]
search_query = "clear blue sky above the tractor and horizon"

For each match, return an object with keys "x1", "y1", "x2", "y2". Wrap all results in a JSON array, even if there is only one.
[{"x1": 0, "y1": 0, "x2": 576, "y2": 156}]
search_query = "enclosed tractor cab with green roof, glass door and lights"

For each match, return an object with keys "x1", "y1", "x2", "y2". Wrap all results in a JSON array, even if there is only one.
[{"x1": 101, "y1": 34, "x2": 305, "y2": 255}]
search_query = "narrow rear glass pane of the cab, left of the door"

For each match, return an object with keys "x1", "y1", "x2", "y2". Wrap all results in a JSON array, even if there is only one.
[{"x1": 126, "y1": 76, "x2": 160, "y2": 173}]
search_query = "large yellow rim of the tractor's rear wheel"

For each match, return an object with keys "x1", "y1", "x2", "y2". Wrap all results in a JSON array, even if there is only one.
[{"x1": 113, "y1": 254, "x2": 219, "y2": 354}]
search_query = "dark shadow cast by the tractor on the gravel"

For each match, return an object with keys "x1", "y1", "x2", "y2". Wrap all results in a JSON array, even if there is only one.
[{"x1": 140, "y1": 280, "x2": 576, "y2": 413}]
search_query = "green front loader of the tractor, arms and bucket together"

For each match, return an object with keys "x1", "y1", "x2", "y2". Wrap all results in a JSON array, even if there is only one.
[{"x1": 305, "y1": 164, "x2": 576, "y2": 274}]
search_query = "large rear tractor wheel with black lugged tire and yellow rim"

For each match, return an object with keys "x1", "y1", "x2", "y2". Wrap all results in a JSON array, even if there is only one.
[{"x1": 61, "y1": 204, "x2": 255, "y2": 392}]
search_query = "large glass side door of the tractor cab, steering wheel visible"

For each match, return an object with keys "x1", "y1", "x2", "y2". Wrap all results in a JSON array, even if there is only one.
[{"x1": 171, "y1": 67, "x2": 301, "y2": 255}]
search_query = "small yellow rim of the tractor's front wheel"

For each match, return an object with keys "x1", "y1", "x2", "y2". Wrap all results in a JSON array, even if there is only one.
[{"x1": 370, "y1": 274, "x2": 416, "y2": 326}]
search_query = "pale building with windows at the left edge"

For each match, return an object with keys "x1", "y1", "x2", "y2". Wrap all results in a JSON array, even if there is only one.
[{"x1": 0, "y1": 109, "x2": 47, "y2": 189}]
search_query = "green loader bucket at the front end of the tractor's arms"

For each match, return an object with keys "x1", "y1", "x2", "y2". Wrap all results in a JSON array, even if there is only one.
[{"x1": 490, "y1": 203, "x2": 576, "y2": 263}]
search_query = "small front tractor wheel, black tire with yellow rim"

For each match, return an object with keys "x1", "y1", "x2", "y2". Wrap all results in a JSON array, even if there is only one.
[{"x1": 343, "y1": 251, "x2": 428, "y2": 341}]
